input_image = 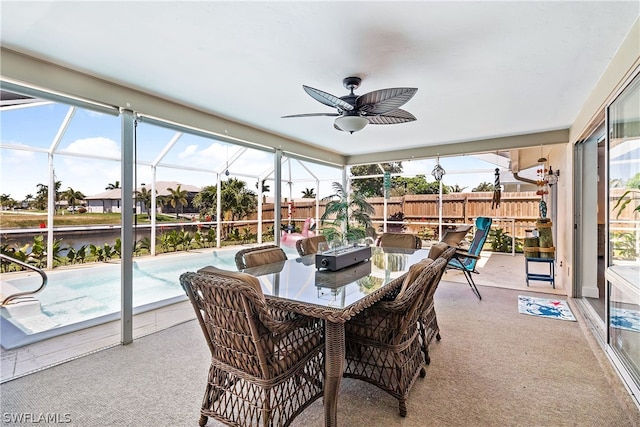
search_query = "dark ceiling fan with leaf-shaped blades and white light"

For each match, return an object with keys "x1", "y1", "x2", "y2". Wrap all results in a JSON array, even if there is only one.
[{"x1": 282, "y1": 77, "x2": 418, "y2": 133}]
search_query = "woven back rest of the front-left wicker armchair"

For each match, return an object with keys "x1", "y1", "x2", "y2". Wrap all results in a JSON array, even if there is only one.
[{"x1": 180, "y1": 268, "x2": 271, "y2": 378}]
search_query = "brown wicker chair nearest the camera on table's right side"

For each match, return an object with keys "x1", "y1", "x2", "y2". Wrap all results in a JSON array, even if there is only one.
[{"x1": 344, "y1": 259, "x2": 447, "y2": 417}]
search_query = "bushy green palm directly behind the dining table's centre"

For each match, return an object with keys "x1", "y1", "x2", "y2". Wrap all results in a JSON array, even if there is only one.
[{"x1": 320, "y1": 182, "x2": 374, "y2": 246}]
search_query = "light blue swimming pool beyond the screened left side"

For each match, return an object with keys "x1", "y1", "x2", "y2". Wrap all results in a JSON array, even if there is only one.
[{"x1": 1, "y1": 247, "x2": 298, "y2": 348}]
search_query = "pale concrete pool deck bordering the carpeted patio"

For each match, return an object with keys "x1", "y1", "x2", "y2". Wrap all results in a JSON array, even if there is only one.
[{"x1": 0, "y1": 248, "x2": 567, "y2": 383}]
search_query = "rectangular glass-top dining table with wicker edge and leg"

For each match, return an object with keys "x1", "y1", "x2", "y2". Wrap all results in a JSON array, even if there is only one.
[{"x1": 243, "y1": 247, "x2": 429, "y2": 426}]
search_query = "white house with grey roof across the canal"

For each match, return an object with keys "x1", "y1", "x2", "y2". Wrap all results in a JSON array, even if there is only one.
[{"x1": 85, "y1": 181, "x2": 200, "y2": 214}]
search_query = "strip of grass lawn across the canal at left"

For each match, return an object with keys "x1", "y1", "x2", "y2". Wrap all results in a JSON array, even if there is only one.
[{"x1": 0, "y1": 211, "x2": 190, "y2": 229}]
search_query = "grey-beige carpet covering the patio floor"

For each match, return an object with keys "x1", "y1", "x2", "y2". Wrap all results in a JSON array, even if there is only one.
[{"x1": 0, "y1": 282, "x2": 640, "y2": 427}]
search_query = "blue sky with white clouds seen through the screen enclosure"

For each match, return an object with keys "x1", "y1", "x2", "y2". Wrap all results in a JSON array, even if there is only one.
[{"x1": 0, "y1": 103, "x2": 495, "y2": 201}]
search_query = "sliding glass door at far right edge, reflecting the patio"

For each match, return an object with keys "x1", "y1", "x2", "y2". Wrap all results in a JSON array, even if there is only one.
[{"x1": 606, "y1": 74, "x2": 640, "y2": 396}]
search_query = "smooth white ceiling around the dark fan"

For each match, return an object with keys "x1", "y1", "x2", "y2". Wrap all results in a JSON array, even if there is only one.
[{"x1": 1, "y1": 0, "x2": 640, "y2": 155}]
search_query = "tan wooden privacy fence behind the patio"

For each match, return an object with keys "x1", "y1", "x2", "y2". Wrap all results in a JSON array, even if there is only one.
[{"x1": 247, "y1": 191, "x2": 540, "y2": 238}]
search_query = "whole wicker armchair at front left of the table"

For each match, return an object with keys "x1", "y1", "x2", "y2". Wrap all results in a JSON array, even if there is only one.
[{"x1": 180, "y1": 267, "x2": 324, "y2": 427}]
